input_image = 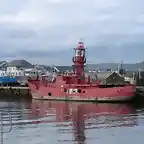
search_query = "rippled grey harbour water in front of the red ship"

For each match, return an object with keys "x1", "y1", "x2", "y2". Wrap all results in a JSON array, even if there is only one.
[{"x1": 0, "y1": 101, "x2": 144, "y2": 144}]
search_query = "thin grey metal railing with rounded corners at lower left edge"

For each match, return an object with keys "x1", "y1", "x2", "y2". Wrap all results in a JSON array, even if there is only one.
[{"x1": 0, "y1": 112, "x2": 12, "y2": 144}]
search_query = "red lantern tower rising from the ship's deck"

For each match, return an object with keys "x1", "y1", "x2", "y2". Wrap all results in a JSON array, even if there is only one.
[{"x1": 73, "y1": 42, "x2": 86, "y2": 76}]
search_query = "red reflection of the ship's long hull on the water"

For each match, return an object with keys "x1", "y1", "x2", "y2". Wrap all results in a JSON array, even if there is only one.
[{"x1": 31, "y1": 100, "x2": 136, "y2": 122}]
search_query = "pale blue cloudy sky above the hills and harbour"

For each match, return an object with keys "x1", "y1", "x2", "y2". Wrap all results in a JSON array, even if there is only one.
[{"x1": 0, "y1": 0, "x2": 144, "y2": 65}]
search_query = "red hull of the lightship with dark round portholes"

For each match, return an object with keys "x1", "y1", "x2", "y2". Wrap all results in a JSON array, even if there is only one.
[{"x1": 29, "y1": 81, "x2": 136, "y2": 102}]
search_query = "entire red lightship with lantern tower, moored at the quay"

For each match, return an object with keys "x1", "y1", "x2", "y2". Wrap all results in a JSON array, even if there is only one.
[{"x1": 29, "y1": 42, "x2": 136, "y2": 101}]
